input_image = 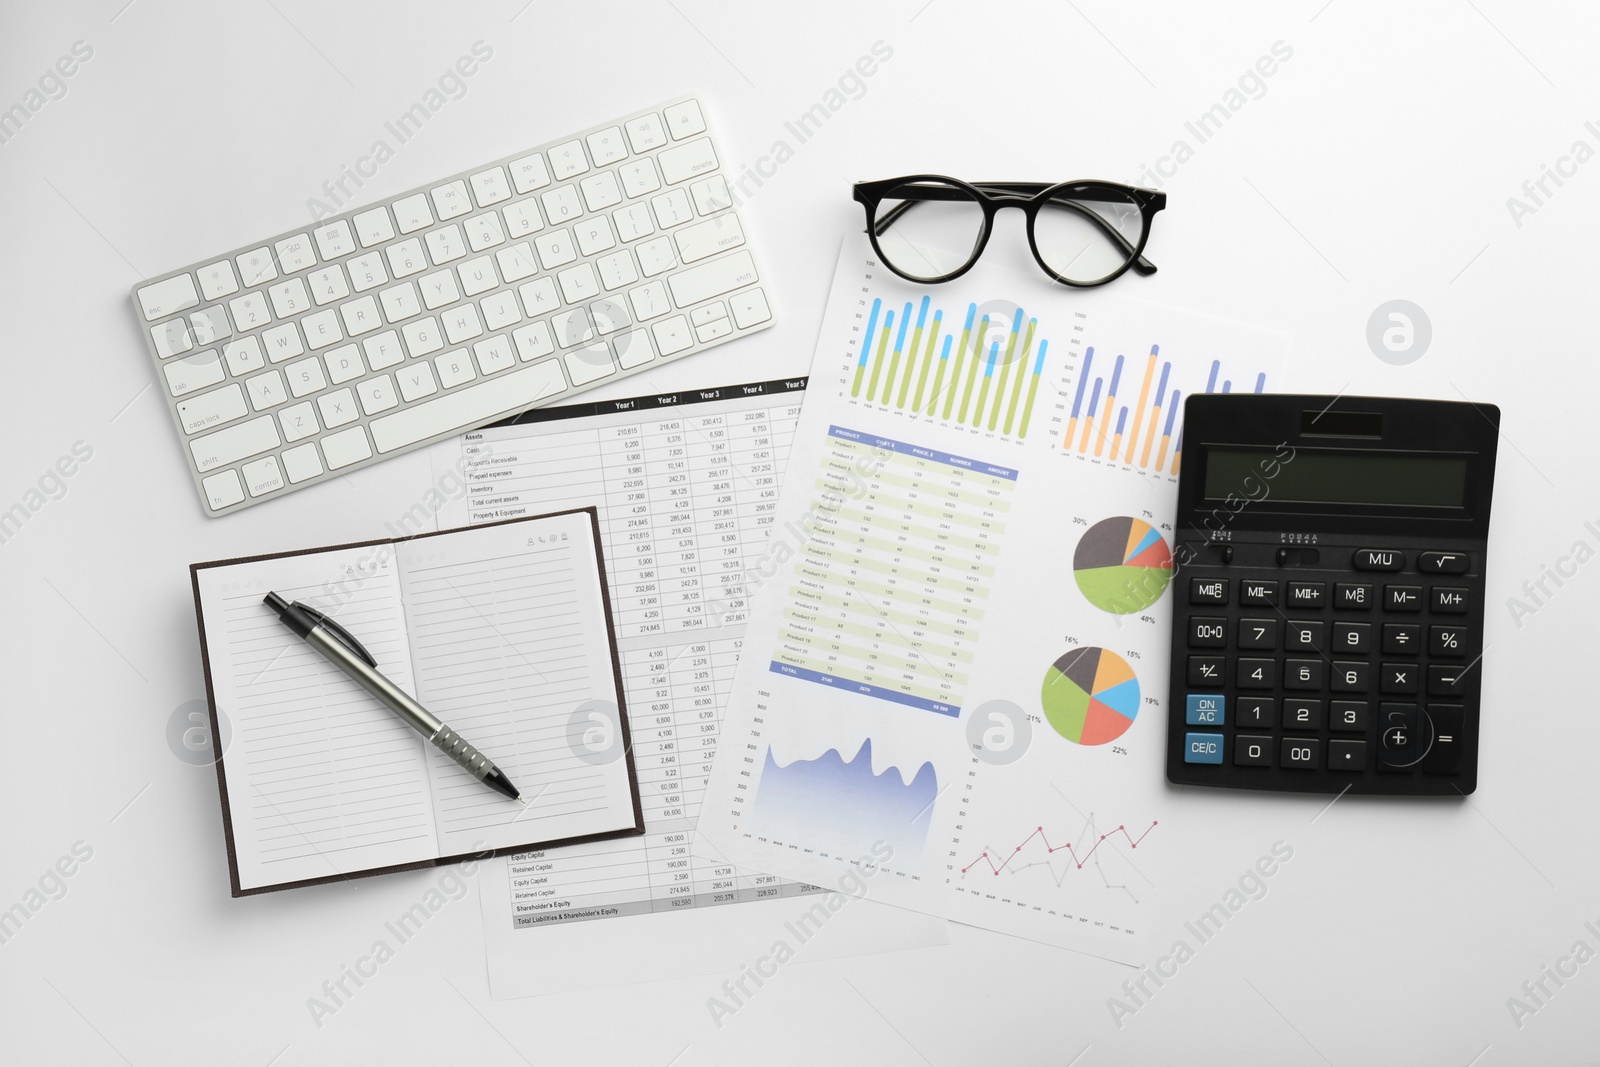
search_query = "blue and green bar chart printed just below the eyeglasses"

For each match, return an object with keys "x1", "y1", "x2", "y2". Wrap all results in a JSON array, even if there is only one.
[{"x1": 850, "y1": 296, "x2": 1050, "y2": 440}]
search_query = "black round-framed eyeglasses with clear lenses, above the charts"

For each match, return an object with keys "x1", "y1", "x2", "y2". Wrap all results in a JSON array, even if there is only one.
[{"x1": 854, "y1": 174, "x2": 1166, "y2": 286}]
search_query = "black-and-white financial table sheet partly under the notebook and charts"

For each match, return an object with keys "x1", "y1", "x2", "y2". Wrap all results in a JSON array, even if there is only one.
[{"x1": 434, "y1": 378, "x2": 946, "y2": 997}]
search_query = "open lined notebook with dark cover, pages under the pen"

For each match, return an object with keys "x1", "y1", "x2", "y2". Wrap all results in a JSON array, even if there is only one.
[{"x1": 190, "y1": 507, "x2": 645, "y2": 896}]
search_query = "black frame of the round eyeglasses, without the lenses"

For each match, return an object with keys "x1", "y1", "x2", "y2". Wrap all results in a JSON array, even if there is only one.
[{"x1": 854, "y1": 174, "x2": 1166, "y2": 290}]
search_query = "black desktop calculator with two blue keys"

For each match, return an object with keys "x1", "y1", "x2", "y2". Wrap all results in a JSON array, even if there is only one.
[{"x1": 1166, "y1": 394, "x2": 1499, "y2": 795}]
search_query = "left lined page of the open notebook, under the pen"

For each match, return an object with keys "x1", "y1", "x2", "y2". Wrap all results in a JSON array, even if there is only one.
[{"x1": 198, "y1": 545, "x2": 438, "y2": 889}]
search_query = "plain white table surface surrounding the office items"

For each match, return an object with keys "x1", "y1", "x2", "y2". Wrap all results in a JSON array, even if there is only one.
[{"x1": 0, "y1": 0, "x2": 1600, "y2": 1067}]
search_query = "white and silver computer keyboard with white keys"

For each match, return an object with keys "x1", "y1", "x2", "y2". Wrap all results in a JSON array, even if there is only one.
[{"x1": 133, "y1": 96, "x2": 773, "y2": 515}]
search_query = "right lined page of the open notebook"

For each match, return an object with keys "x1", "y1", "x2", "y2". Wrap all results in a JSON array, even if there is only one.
[{"x1": 398, "y1": 514, "x2": 635, "y2": 856}]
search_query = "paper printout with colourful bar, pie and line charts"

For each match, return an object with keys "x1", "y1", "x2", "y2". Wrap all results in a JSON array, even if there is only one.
[{"x1": 696, "y1": 240, "x2": 1286, "y2": 961}]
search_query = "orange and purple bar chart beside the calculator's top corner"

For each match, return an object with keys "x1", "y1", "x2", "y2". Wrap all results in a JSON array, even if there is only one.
[{"x1": 1061, "y1": 344, "x2": 1267, "y2": 475}]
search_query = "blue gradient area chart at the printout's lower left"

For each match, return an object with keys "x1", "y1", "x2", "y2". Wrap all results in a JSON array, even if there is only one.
[{"x1": 750, "y1": 737, "x2": 939, "y2": 869}]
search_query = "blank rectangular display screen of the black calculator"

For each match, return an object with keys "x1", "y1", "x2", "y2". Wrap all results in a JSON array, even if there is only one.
[{"x1": 1205, "y1": 446, "x2": 1467, "y2": 507}]
